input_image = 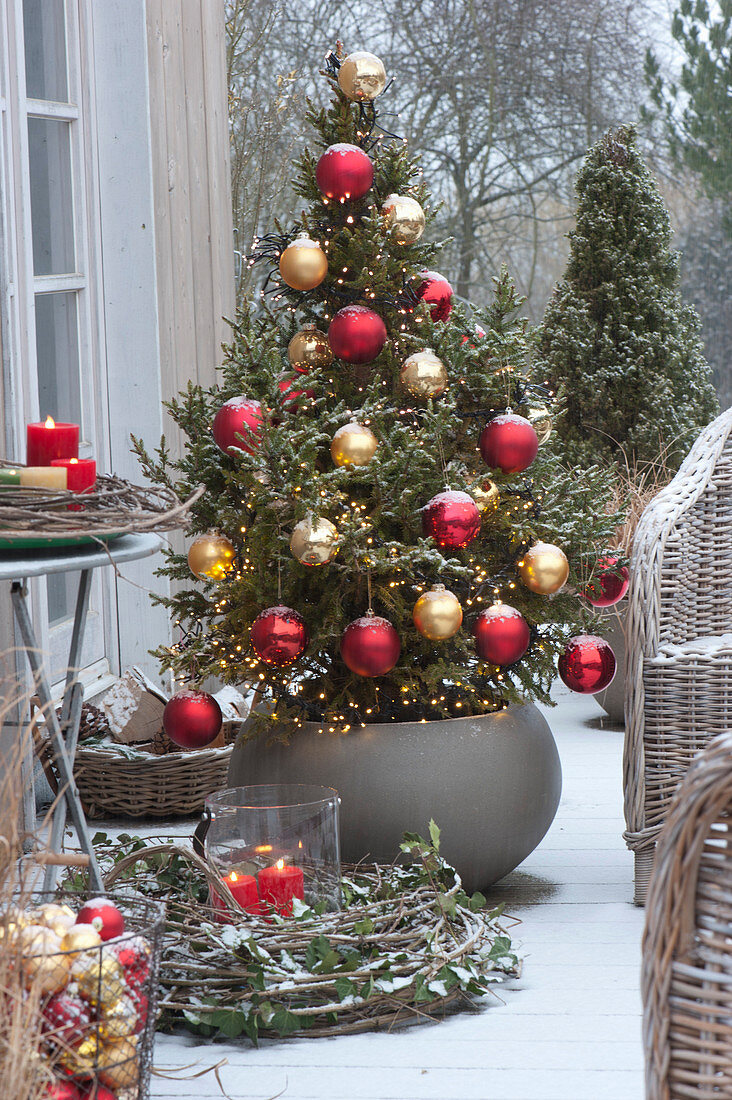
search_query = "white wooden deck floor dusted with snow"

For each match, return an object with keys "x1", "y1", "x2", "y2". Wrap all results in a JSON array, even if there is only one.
[{"x1": 79, "y1": 689, "x2": 643, "y2": 1100}]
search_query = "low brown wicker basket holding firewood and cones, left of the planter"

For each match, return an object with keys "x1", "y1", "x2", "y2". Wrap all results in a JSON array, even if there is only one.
[{"x1": 39, "y1": 721, "x2": 241, "y2": 817}]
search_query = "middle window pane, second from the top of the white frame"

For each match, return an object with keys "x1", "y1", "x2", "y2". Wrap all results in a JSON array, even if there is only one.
[{"x1": 28, "y1": 119, "x2": 76, "y2": 275}]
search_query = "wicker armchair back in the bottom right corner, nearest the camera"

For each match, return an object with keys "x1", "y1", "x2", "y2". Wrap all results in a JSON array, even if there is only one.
[{"x1": 641, "y1": 734, "x2": 732, "y2": 1100}]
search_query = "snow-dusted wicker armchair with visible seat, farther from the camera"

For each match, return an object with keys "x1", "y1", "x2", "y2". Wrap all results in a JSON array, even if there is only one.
[{"x1": 623, "y1": 409, "x2": 732, "y2": 905}]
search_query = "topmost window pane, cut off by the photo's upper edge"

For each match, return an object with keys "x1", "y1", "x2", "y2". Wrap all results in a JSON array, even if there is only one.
[{"x1": 23, "y1": 0, "x2": 68, "y2": 102}]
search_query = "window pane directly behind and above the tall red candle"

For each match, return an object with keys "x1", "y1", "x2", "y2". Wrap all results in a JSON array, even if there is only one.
[{"x1": 35, "y1": 290, "x2": 81, "y2": 424}]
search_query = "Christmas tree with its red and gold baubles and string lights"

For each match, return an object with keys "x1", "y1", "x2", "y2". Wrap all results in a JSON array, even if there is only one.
[{"x1": 135, "y1": 53, "x2": 618, "y2": 733}]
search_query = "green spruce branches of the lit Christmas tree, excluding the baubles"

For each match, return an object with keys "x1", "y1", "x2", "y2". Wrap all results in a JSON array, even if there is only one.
[{"x1": 135, "y1": 55, "x2": 618, "y2": 736}]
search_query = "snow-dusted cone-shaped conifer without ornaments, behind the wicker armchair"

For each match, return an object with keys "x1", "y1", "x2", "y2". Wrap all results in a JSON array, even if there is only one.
[{"x1": 537, "y1": 127, "x2": 718, "y2": 468}]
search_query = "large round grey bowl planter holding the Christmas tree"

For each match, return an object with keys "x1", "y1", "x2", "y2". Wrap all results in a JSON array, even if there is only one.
[{"x1": 228, "y1": 703, "x2": 561, "y2": 892}]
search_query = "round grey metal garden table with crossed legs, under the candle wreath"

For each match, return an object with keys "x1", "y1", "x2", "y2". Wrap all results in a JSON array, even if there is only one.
[{"x1": 0, "y1": 535, "x2": 162, "y2": 893}]
